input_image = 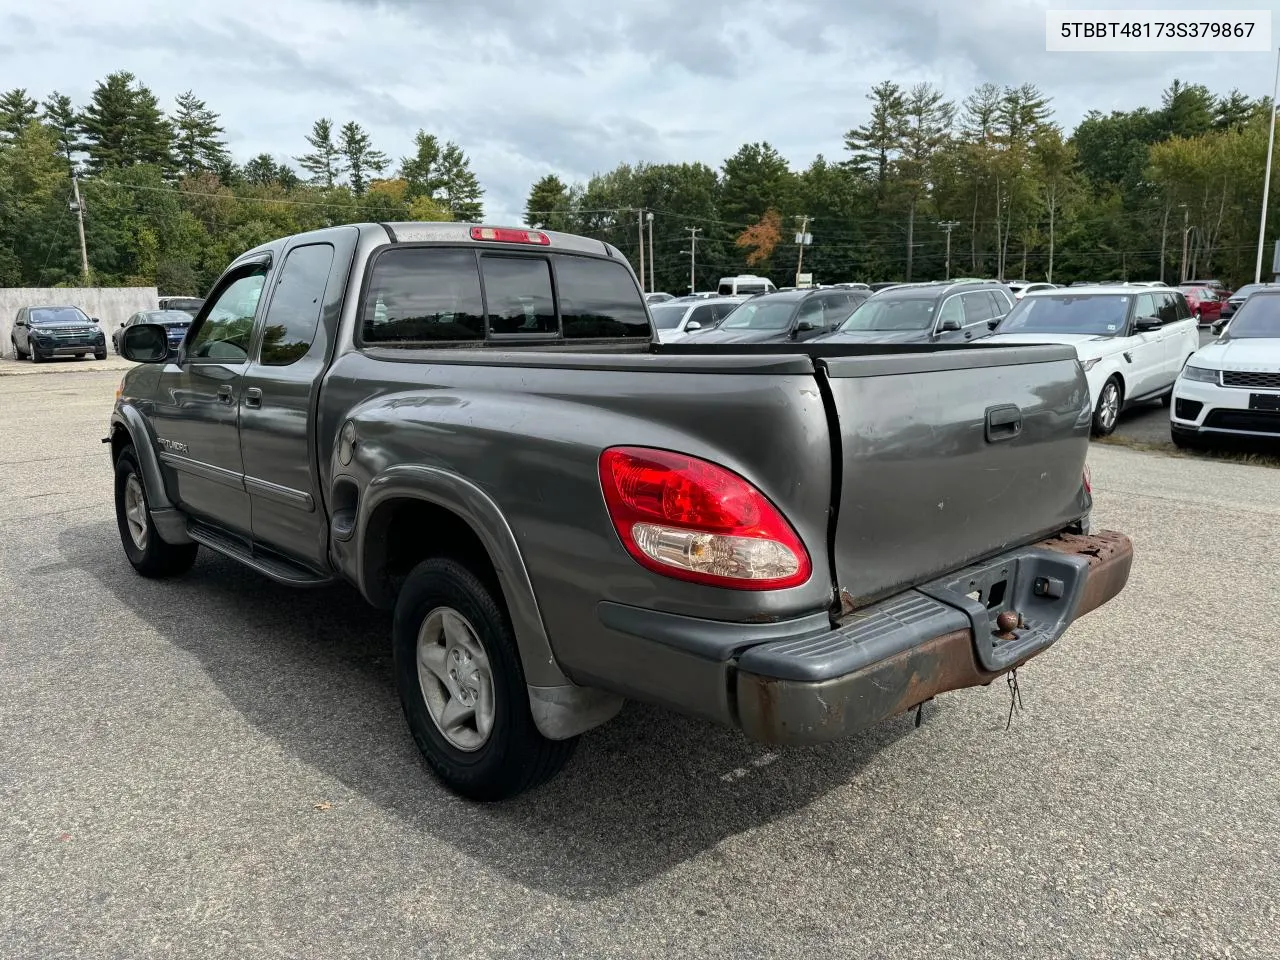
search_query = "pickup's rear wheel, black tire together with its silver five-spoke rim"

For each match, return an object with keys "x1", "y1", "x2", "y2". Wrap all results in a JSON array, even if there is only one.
[{"x1": 392, "y1": 557, "x2": 576, "y2": 800}]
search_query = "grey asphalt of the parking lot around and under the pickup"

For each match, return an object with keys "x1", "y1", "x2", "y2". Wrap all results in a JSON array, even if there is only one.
[{"x1": 0, "y1": 372, "x2": 1280, "y2": 959}]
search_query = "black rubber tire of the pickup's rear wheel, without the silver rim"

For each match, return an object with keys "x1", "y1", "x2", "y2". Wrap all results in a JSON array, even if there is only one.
[{"x1": 392, "y1": 557, "x2": 577, "y2": 801}]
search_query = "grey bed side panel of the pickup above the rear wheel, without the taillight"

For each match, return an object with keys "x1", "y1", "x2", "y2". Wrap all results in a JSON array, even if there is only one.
[{"x1": 320, "y1": 351, "x2": 832, "y2": 692}]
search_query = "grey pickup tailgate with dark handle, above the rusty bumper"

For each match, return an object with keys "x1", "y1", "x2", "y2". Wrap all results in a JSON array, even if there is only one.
[{"x1": 819, "y1": 346, "x2": 1092, "y2": 605}]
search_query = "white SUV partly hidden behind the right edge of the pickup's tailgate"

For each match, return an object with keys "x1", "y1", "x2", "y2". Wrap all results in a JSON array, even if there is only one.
[{"x1": 991, "y1": 285, "x2": 1199, "y2": 436}]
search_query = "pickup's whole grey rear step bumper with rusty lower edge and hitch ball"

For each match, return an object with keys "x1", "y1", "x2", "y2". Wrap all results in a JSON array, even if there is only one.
[{"x1": 588, "y1": 531, "x2": 1133, "y2": 744}]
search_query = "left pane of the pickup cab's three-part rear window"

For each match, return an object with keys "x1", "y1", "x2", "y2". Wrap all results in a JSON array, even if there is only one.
[{"x1": 361, "y1": 247, "x2": 484, "y2": 344}]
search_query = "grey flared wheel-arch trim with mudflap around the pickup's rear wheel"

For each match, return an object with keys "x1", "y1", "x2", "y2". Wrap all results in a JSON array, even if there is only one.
[{"x1": 350, "y1": 465, "x2": 622, "y2": 740}]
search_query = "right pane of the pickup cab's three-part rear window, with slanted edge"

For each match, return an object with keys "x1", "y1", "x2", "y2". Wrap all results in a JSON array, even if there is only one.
[{"x1": 554, "y1": 255, "x2": 652, "y2": 339}]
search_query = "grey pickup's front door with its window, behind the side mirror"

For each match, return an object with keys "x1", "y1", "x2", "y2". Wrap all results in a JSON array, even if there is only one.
[{"x1": 152, "y1": 261, "x2": 269, "y2": 536}]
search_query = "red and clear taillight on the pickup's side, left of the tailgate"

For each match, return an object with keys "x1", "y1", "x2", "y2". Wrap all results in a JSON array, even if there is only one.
[{"x1": 600, "y1": 447, "x2": 813, "y2": 590}]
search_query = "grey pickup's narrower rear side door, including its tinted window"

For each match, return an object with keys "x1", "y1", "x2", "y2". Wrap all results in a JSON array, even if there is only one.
[{"x1": 239, "y1": 243, "x2": 347, "y2": 568}]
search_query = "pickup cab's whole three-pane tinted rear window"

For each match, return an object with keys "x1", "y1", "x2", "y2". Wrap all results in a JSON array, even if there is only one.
[{"x1": 361, "y1": 247, "x2": 650, "y2": 344}]
